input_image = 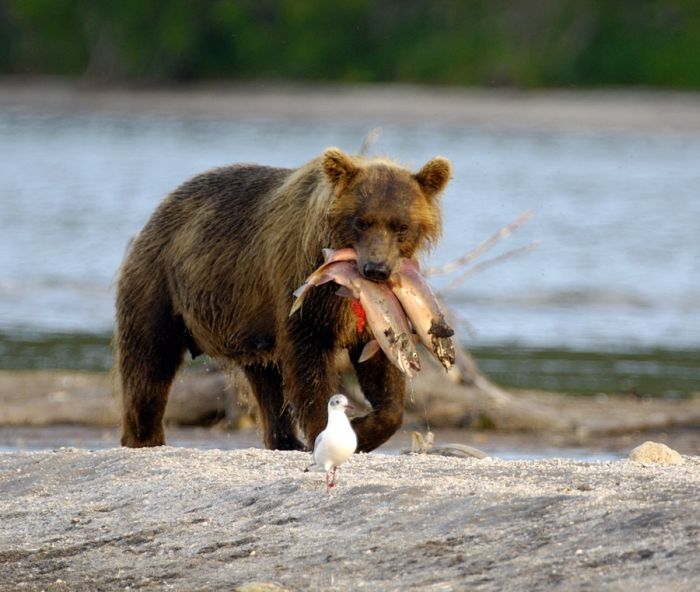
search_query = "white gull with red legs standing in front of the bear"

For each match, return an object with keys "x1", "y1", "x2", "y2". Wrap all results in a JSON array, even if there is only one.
[{"x1": 306, "y1": 395, "x2": 357, "y2": 495}]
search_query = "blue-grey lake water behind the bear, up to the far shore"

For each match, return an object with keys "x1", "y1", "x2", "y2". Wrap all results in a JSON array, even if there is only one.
[{"x1": 0, "y1": 109, "x2": 700, "y2": 394}]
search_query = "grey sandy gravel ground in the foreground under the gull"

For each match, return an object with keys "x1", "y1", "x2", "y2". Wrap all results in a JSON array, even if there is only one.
[{"x1": 0, "y1": 448, "x2": 700, "y2": 591}]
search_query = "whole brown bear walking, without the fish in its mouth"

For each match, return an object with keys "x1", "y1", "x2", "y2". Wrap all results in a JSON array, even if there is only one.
[{"x1": 115, "y1": 148, "x2": 451, "y2": 451}]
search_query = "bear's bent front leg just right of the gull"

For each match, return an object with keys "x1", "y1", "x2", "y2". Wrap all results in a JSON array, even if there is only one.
[{"x1": 350, "y1": 344, "x2": 406, "y2": 452}]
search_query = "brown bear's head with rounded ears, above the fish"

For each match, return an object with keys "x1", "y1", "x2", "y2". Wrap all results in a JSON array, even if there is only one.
[{"x1": 322, "y1": 148, "x2": 452, "y2": 281}]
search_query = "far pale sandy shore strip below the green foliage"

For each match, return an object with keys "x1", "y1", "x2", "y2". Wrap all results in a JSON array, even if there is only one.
[{"x1": 0, "y1": 78, "x2": 700, "y2": 132}]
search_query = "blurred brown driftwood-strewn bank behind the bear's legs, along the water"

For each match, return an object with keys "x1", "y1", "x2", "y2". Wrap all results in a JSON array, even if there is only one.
[{"x1": 0, "y1": 368, "x2": 700, "y2": 440}]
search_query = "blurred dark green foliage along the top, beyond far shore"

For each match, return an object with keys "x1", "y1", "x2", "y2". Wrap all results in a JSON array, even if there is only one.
[{"x1": 0, "y1": 0, "x2": 700, "y2": 88}]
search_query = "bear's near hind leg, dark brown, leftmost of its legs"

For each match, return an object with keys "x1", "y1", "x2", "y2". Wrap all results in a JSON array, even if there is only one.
[{"x1": 117, "y1": 294, "x2": 185, "y2": 448}]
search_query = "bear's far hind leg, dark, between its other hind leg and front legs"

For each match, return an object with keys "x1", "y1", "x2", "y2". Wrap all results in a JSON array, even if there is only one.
[{"x1": 244, "y1": 364, "x2": 304, "y2": 450}]
